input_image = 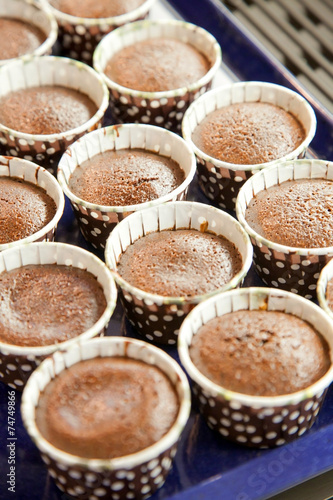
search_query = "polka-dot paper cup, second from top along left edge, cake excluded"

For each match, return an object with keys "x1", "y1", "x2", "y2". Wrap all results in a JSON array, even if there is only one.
[{"x1": 0, "y1": 56, "x2": 108, "y2": 173}]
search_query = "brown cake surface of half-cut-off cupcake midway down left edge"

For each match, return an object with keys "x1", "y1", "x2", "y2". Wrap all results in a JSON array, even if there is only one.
[{"x1": 0, "y1": 177, "x2": 57, "y2": 244}]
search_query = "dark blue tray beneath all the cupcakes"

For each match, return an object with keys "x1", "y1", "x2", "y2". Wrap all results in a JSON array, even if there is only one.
[{"x1": 0, "y1": 0, "x2": 333, "y2": 500}]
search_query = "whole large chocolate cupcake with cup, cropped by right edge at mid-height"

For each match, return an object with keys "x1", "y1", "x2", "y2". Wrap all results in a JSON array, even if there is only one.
[{"x1": 236, "y1": 160, "x2": 333, "y2": 299}]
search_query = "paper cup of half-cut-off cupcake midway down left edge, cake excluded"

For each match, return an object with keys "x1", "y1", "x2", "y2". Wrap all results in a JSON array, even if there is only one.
[{"x1": 0, "y1": 156, "x2": 65, "y2": 252}]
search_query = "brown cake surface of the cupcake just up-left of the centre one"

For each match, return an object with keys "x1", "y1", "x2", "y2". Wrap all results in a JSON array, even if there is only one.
[{"x1": 68, "y1": 149, "x2": 185, "y2": 206}]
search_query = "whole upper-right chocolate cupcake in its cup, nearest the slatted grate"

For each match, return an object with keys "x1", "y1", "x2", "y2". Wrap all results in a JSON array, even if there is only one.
[{"x1": 182, "y1": 82, "x2": 316, "y2": 210}]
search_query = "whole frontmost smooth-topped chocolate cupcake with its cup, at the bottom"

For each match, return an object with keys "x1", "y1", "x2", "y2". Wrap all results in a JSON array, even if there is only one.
[{"x1": 21, "y1": 337, "x2": 191, "y2": 500}]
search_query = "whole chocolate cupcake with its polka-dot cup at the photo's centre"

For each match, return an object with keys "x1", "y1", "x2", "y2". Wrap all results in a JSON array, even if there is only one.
[{"x1": 105, "y1": 202, "x2": 252, "y2": 345}]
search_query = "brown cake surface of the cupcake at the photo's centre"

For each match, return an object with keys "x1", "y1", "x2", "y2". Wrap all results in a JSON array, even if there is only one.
[{"x1": 117, "y1": 229, "x2": 242, "y2": 297}]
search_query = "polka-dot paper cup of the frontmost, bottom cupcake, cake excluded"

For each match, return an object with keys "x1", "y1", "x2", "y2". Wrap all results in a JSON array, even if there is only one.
[{"x1": 21, "y1": 337, "x2": 191, "y2": 500}]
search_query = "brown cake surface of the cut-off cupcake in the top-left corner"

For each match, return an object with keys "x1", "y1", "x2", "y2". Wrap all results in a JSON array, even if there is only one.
[{"x1": 0, "y1": 17, "x2": 46, "y2": 59}]
